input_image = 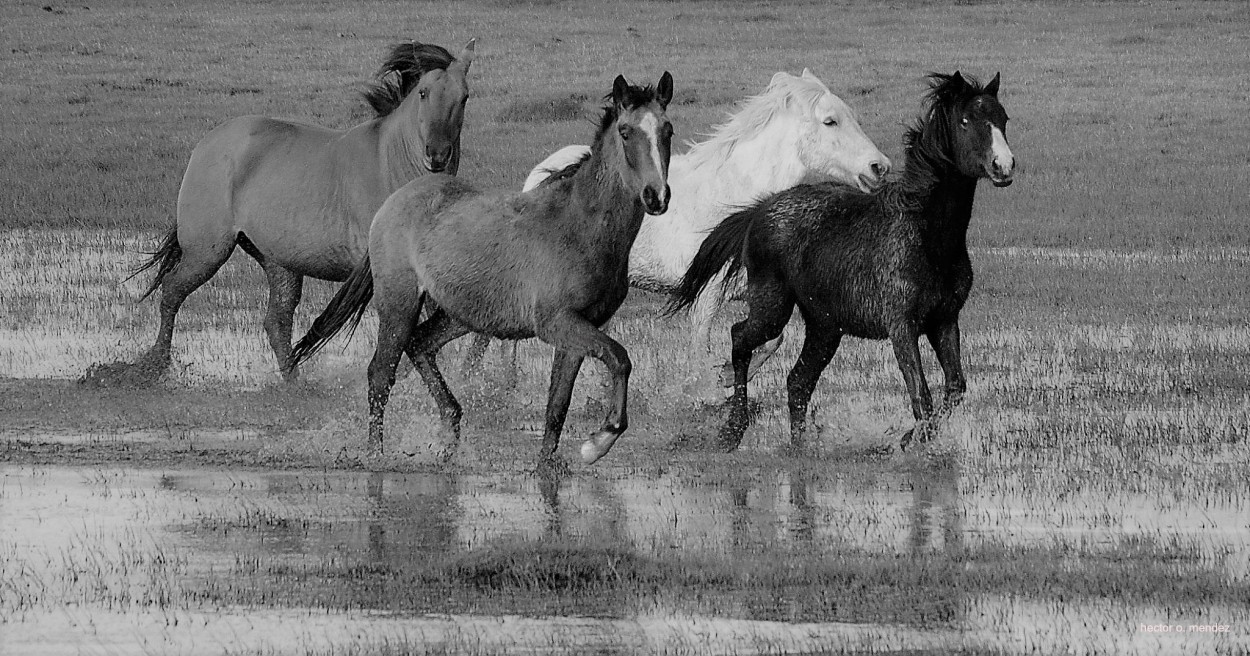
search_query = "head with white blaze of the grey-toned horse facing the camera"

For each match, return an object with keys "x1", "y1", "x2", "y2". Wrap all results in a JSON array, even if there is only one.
[{"x1": 604, "y1": 71, "x2": 673, "y2": 215}]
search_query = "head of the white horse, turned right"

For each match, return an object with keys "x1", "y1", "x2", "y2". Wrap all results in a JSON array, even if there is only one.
[{"x1": 766, "y1": 69, "x2": 890, "y2": 191}]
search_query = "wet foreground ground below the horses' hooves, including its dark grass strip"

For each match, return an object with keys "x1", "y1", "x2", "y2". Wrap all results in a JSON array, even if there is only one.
[{"x1": 0, "y1": 427, "x2": 1250, "y2": 655}]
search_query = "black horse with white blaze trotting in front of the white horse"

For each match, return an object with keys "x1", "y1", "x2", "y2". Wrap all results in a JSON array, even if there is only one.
[{"x1": 670, "y1": 71, "x2": 1015, "y2": 451}]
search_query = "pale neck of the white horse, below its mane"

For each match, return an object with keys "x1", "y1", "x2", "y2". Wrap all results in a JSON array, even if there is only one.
[{"x1": 683, "y1": 120, "x2": 809, "y2": 197}]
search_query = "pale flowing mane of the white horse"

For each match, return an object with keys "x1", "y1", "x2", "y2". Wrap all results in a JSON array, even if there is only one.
[{"x1": 685, "y1": 75, "x2": 830, "y2": 162}]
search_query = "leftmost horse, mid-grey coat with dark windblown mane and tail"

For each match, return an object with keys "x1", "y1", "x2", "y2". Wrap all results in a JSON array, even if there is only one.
[{"x1": 84, "y1": 40, "x2": 474, "y2": 385}]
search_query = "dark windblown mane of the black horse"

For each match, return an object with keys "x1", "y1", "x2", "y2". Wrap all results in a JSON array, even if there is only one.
[{"x1": 878, "y1": 72, "x2": 985, "y2": 212}]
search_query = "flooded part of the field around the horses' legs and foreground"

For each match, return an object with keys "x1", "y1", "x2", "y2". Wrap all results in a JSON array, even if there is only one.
[{"x1": 0, "y1": 231, "x2": 1250, "y2": 656}]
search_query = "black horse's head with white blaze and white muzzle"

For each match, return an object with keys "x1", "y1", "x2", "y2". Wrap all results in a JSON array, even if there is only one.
[{"x1": 930, "y1": 71, "x2": 1015, "y2": 186}]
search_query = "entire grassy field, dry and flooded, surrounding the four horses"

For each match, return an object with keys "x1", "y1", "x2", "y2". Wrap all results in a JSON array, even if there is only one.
[{"x1": 0, "y1": 1, "x2": 1250, "y2": 655}]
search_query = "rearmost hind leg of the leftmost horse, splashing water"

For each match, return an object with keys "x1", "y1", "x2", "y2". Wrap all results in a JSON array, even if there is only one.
[{"x1": 134, "y1": 236, "x2": 238, "y2": 376}]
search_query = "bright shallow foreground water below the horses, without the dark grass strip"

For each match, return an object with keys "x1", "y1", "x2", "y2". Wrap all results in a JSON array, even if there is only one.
[{"x1": 0, "y1": 457, "x2": 1250, "y2": 655}]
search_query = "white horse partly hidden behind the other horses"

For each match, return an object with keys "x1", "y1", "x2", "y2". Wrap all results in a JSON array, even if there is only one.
[{"x1": 470, "y1": 69, "x2": 890, "y2": 381}]
